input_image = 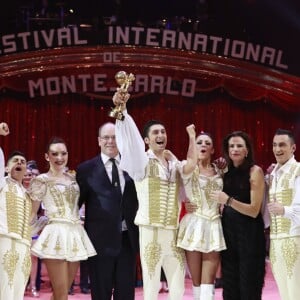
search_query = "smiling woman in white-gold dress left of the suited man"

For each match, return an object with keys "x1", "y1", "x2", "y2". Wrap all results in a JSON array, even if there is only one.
[{"x1": 28, "y1": 137, "x2": 96, "y2": 300}]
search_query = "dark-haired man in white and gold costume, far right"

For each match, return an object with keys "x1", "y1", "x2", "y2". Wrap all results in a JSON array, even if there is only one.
[{"x1": 268, "y1": 129, "x2": 300, "y2": 300}]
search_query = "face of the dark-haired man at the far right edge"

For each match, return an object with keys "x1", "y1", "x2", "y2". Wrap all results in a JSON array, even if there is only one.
[{"x1": 273, "y1": 134, "x2": 296, "y2": 165}]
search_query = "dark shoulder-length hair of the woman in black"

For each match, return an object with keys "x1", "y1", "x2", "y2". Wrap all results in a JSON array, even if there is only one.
[{"x1": 223, "y1": 131, "x2": 254, "y2": 170}]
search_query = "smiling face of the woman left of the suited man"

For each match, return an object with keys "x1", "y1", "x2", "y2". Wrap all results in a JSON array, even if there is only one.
[{"x1": 45, "y1": 143, "x2": 68, "y2": 173}]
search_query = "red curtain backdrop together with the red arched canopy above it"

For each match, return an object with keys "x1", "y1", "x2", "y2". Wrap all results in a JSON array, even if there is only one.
[{"x1": 0, "y1": 47, "x2": 300, "y2": 171}]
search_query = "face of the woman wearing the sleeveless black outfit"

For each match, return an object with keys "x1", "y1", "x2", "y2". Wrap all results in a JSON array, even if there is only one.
[{"x1": 228, "y1": 136, "x2": 248, "y2": 166}]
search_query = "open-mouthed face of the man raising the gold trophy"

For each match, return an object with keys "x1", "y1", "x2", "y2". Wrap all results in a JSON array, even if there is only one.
[{"x1": 144, "y1": 124, "x2": 167, "y2": 153}]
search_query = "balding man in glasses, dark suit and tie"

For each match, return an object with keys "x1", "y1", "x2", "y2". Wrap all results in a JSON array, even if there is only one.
[{"x1": 76, "y1": 123, "x2": 138, "y2": 300}]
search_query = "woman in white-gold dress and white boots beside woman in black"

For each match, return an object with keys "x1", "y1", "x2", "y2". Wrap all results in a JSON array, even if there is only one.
[{"x1": 177, "y1": 132, "x2": 226, "y2": 300}]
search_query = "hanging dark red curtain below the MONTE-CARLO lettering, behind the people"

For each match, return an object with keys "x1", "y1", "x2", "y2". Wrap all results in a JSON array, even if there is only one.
[{"x1": 0, "y1": 89, "x2": 300, "y2": 171}]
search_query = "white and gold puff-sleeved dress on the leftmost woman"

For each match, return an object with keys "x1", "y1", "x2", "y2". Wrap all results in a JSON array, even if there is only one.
[{"x1": 28, "y1": 173, "x2": 96, "y2": 261}]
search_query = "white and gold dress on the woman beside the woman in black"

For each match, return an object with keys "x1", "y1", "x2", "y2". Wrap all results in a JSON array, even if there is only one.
[{"x1": 177, "y1": 167, "x2": 226, "y2": 253}]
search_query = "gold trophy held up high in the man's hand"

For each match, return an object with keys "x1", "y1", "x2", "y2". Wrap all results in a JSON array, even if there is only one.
[{"x1": 108, "y1": 71, "x2": 135, "y2": 121}]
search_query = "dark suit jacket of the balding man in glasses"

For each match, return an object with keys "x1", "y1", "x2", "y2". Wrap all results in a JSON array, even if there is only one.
[{"x1": 76, "y1": 155, "x2": 139, "y2": 256}]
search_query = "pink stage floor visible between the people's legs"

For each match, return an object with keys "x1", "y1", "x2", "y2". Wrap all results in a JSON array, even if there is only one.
[{"x1": 24, "y1": 263, "x2": 280, "y2": 300}]
